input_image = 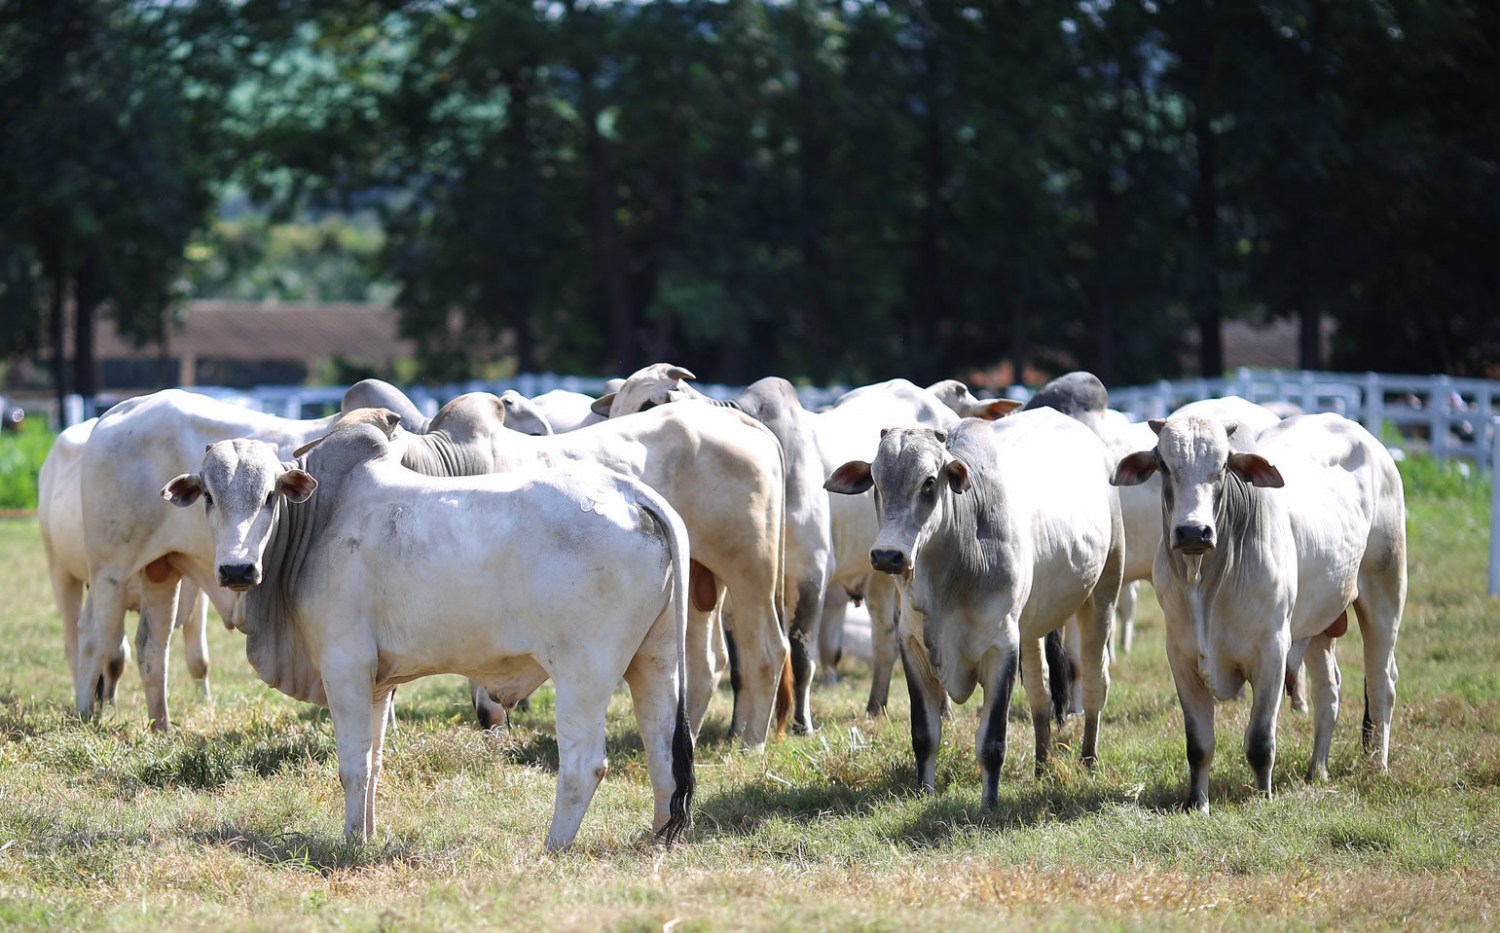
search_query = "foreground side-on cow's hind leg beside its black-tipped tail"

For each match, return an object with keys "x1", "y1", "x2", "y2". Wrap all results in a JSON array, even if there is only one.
[{"x1": 626, "y1": 611, "x2": 681, "y2": 833}]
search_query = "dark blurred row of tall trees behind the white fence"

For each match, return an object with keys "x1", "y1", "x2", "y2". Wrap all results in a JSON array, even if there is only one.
[{"x1": 0, "y1": 0, "x2": 1500, "y2": 396}]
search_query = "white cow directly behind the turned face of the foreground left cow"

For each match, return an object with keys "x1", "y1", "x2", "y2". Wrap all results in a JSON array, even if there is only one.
[{"x1": 74, "y1": 389, "x2": 348, "y2": 731}]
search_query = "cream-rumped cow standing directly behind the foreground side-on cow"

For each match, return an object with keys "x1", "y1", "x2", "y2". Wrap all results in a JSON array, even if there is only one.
[{"x1": 354, "y1": 392, "x2": 791, "y2": 747}]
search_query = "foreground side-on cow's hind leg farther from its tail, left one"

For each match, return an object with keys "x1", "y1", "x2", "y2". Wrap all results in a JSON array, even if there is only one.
[{"x1": 546, "y1": 677, "x2": 615, "y2": 852}]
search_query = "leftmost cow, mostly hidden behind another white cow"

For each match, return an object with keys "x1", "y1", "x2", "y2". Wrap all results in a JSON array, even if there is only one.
[{"x1": 36, "y1": 419, "x2": 209, "y2": 701}]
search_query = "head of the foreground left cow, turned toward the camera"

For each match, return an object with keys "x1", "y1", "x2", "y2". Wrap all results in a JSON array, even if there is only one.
[{"x1": 162, "y1": 438, "x2": 318, "y2": 593}]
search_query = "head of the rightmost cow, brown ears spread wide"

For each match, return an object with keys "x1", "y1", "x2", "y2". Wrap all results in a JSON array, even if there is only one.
[{"x1": 1110, "y1": 416, "x2": 1283, "y2": 557}]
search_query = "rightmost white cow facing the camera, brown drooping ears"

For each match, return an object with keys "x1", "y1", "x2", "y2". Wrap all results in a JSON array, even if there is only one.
[{"x1": 1113, "y1": 414, "x2": 1406, "y2": 812}]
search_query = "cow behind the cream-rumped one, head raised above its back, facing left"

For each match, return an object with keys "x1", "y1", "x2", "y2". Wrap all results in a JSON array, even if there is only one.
[{"x1": 594, "y1": 363, "x2": 833, "y2": 732}]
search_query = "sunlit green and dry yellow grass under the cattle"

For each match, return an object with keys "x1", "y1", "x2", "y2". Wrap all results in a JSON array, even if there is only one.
[{"x1": 0, "y1": 474, "x2": 1500, "y2": 930}]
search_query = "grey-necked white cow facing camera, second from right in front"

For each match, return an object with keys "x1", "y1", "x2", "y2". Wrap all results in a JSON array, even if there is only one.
[{"x1": 828, "y1": 410, "x2": 1124, "y2": 807}]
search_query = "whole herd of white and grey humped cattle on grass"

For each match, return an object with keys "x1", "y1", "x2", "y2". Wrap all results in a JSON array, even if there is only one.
[{"x1": 38, "y1": 365, "x2": 1406, "y2": 849}]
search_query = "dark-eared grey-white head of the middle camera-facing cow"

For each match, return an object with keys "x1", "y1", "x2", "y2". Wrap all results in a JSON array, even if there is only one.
[{"x1": 824, "y1": 428, "x2": 969, "y2": 575}]
